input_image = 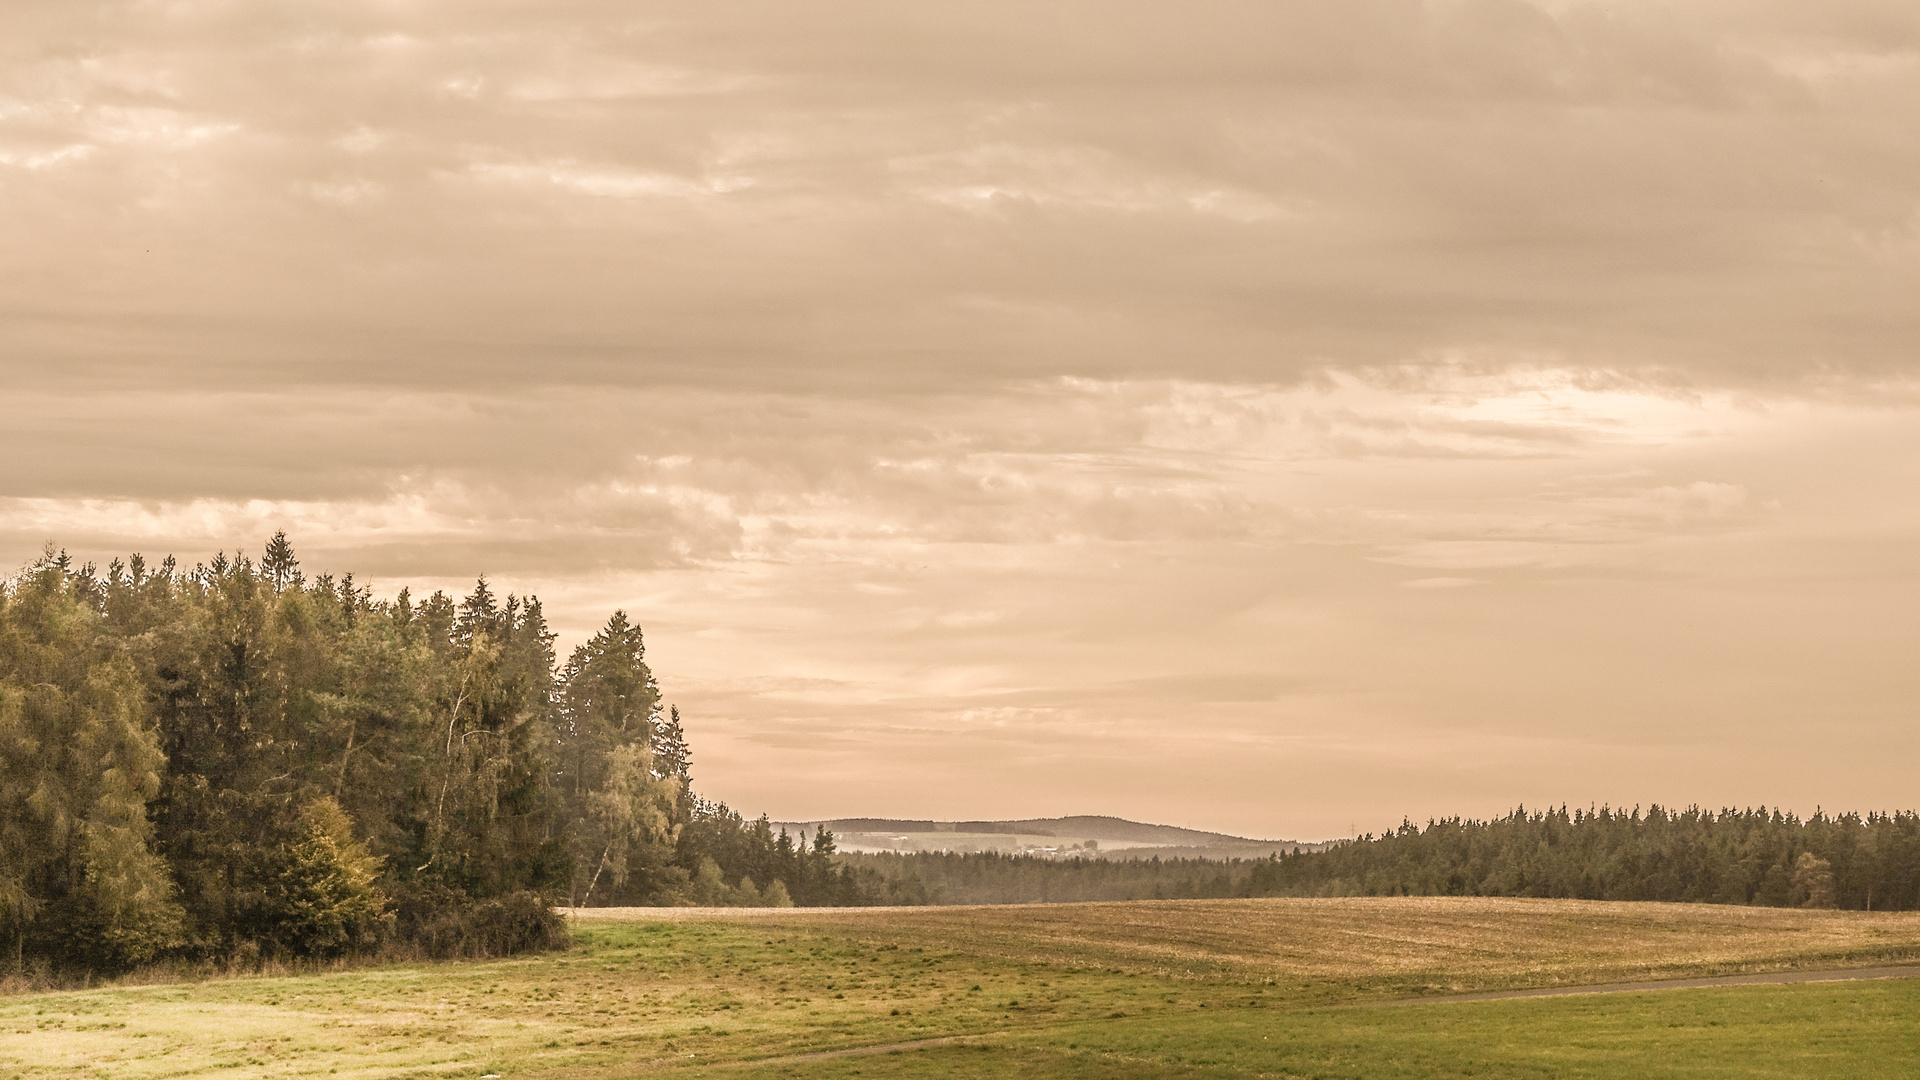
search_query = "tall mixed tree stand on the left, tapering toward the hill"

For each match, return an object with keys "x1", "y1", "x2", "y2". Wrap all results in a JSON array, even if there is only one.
[{"x1": 0, "y1": 534, "x2": 902, "y2": 970}]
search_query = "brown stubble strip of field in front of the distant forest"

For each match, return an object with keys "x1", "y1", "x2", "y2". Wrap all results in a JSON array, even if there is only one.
[{"x1": 580, "y1": 897, "x2": 1920, "y2": 994}]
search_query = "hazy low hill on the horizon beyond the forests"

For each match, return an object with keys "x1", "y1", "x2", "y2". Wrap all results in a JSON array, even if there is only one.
[{"x1": 776, "y1": 815, "x2": 1319, "y2": 859}]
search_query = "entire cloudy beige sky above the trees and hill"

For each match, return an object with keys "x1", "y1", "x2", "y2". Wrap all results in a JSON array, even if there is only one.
[{"x1": 0, "y1": 0, "x2": 1920, "y2": 840}]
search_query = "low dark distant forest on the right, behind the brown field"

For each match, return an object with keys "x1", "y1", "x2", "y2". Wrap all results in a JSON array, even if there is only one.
[{"x1": 843, "y1": 807, "x2": 1920, "y2": 911}]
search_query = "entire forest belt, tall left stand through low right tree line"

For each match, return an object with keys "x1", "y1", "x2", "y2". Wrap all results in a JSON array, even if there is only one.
[{"x1": 0, "y1": 534, "x2": 1920, "y2": 970}]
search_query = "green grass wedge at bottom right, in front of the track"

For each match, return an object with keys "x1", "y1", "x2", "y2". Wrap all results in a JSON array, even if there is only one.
[{"x1": 710, "y1": 980, "x2": 1920, "y2": 1080}]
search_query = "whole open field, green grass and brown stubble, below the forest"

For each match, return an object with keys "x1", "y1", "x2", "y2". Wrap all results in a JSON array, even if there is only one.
[{"x1": 0, "y1": 899, "x2": 1920, "y2": 1080}]
